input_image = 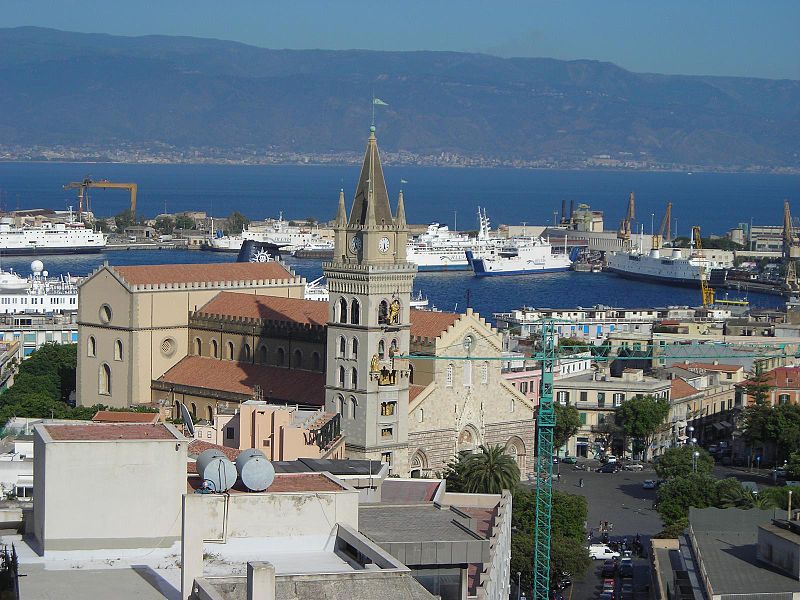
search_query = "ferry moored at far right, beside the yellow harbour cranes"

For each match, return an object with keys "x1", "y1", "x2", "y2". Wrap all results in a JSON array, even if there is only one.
[{"x1": 607, "y1": 232, "x2": 733, "y2": 286}]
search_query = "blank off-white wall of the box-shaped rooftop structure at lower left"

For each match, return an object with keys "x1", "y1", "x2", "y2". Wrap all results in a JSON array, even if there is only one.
[{"x1": 34, "y1": 425, "x2": 188, "y2": 551}]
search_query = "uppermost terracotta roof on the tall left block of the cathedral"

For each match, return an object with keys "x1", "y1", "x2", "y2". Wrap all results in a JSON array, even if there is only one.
[{"x1": 111, "y1": 262, "x2": 292, "y2": 285}]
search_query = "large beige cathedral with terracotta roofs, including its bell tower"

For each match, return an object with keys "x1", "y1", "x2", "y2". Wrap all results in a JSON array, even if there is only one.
[{"x1": 78, "y1": 127, "x2": 535, "y2": 477}]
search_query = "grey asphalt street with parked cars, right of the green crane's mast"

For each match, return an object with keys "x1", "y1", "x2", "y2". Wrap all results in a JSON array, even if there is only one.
[{"x1": 553, "y1": 461, "x2": 661, "y2": 600}]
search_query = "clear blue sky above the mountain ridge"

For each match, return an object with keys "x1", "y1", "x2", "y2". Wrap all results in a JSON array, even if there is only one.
[{"x1": 6, "y1": 0, "x2": 800, "y2": 79}]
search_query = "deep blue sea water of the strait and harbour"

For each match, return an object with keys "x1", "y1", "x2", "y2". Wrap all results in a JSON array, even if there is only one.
[{"x1": 0, "y1": 162, "x2": 800, "y2": 319}]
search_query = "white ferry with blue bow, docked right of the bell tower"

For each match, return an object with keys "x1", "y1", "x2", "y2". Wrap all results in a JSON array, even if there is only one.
[{"x1": 467, "y1": 237, "x2": 573, "y2": 277}]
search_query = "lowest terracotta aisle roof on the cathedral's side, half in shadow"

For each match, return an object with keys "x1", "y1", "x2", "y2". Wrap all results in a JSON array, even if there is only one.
[{"x1": 158, "y1": 356, "x2": 325, "y2": 406}]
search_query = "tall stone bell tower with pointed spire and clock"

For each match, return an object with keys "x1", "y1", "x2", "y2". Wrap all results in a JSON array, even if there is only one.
[{"x1": 323, "y1": 126, "x2": 416, "y2": 476}]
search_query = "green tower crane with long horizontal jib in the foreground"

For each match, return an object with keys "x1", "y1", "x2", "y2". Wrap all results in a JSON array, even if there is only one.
[{"x1": 394, "y1": 330, "x2": 800, "y2": 600}]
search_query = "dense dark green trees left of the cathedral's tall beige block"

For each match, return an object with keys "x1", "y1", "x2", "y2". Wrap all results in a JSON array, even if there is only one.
[{"x1": 0, "y1": 343, "x2": 102, "y2": 423}]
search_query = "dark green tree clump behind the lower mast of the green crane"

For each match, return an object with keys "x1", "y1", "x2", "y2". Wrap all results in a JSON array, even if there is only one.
[{"x1": 511, "y1": 486, "x2": 591, "y2": 598}]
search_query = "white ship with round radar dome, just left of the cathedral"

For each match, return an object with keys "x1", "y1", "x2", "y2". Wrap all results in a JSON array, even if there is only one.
[{"x1": 0, "y1": 260, "x2": 78, "y2": 314}]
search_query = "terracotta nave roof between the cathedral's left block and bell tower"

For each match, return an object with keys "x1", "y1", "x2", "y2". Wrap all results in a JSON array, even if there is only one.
[{"x1": 197, "y1": 292, "x2": 328, "y2": 326}]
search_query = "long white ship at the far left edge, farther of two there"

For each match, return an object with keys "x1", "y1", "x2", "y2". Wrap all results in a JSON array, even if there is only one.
[{"x1": 0, "y1": 217, "x2": 108, "y2": 256}]
